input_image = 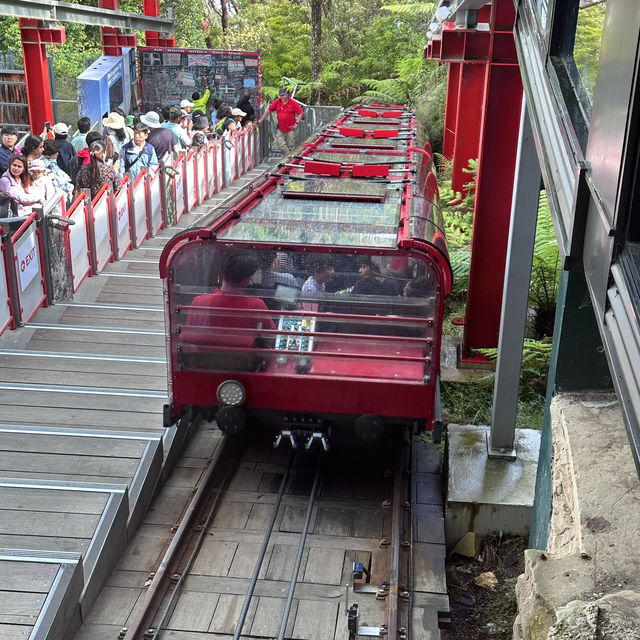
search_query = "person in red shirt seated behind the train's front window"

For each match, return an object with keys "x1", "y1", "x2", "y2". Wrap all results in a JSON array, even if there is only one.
[{"x1": 187, "y1": 250, "x2": 276, "y2": 347}]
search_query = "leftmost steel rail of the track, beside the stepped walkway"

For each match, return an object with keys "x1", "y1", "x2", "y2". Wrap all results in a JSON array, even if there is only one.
[{"x1": 123, "y1": 430, "x2": 235, "y2": 640}]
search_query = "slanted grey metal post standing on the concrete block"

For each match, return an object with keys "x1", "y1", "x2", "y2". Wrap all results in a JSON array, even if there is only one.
[{"x1": 489, "y1": 99, "x2": 541, "y2": 458}]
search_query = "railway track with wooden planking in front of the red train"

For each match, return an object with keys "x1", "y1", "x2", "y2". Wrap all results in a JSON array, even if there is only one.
[{"x1": 120, "y1": 424, "x2": 446, "y2": 640}]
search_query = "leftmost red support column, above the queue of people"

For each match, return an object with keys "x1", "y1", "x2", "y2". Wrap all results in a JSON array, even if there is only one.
[{"x1": 20, "y1": 18, "x2": 66, "y2": 135}]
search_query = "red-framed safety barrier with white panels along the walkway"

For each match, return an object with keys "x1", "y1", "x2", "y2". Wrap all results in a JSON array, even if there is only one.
[{"x1": 0, "y1": 125, "x2": 263, "y2": 335}]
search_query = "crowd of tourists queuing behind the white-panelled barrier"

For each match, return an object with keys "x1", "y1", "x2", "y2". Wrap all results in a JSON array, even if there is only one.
[{"x1": 0, "y1": 83, "x2": 262, "y2": 217}]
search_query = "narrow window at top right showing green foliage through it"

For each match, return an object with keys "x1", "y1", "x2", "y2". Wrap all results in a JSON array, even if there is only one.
[{"x1": 550, "y1": 0, "x2": 607, "y2": 146}]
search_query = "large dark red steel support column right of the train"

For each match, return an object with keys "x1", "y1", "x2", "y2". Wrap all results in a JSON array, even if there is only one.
[{"x1": 426, "y1": 0, "x2": 522, "y2": 359}]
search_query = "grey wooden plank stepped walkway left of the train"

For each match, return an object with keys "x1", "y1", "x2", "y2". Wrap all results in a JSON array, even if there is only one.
[{"x1": 0, "y1": 166, "x2": 266, "y2": 640}]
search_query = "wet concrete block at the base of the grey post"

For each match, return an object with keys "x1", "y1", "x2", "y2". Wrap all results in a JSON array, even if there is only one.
[{"x1": 445, "y1": 424, "x2": 540, "y2": 549}]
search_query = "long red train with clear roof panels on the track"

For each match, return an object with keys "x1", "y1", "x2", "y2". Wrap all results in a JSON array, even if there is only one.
[{"x1": 160, "y1": 105, "x2": 451, "y2": 447}]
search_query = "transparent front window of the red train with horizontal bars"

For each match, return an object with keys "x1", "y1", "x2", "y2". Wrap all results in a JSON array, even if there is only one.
[{"x1": 168, "y1": 241, "x2": 440, "y2": 384}]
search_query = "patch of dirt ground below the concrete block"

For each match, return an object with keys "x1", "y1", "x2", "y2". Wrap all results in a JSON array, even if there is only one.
[{"x1": 441, "y1": 533, "x2": 527, "y2": 640}]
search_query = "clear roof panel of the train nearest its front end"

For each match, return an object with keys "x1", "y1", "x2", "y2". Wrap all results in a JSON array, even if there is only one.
[{"x1": 218, "y1": 185, "x2": 401, "y2": 247}]
